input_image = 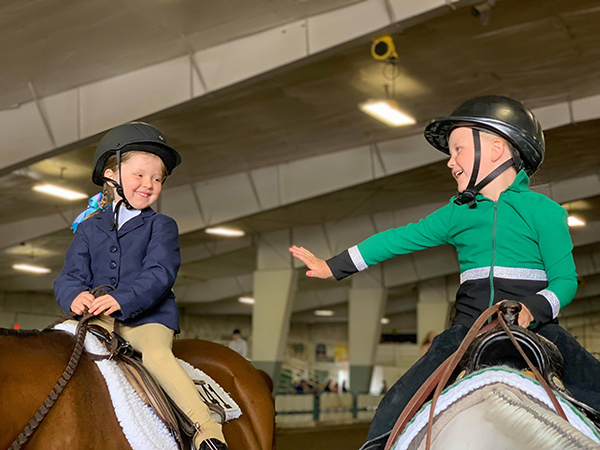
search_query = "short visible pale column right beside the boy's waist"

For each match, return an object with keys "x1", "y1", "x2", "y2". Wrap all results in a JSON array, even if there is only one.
[{"x1": 417, "y1": 277, "x2": 457, "y2": 343}]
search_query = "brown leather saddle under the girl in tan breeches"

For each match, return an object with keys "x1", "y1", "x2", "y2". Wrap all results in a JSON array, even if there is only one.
[{"x1": 87, "y1": 321, "x2": 225, "y2": 450}]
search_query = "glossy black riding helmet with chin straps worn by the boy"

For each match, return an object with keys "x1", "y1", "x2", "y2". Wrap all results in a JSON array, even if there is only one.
[{"x1": 425, "y1": 95, "x2": 545, "y2": 207}]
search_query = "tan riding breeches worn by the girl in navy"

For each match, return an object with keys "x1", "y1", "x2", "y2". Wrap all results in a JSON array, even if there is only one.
[{"x1": 69, "y1": 315, "x2": 225, "y2": 444}]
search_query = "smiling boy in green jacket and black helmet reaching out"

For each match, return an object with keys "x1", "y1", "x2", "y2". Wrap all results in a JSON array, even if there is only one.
[{"x1": 290, "y1": 96, "x2": 600, "y2": 450}]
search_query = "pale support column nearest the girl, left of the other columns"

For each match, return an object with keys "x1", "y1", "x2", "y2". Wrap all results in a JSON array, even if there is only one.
[{"x1": 252, "y1": 230, "x2": 297, "y2": 386}]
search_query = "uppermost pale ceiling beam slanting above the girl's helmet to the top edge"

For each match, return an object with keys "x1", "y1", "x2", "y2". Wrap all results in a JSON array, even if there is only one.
[{"x1": 0, "y1": 0, "x2": 474, "y2": 174}]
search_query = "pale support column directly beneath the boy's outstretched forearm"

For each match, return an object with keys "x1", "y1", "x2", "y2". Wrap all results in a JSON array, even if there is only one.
[{"x1": 348, "y1": 266, "x2": 387, "y2": 393}]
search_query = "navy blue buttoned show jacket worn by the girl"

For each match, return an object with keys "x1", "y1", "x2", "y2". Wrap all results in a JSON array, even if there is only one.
[{"x1": 54, "y1": 206, "x2": 181, "y2": 333}]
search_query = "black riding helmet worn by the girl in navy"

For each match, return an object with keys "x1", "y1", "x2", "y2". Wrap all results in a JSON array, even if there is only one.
[{"x1": 92, "y1": 122, "x2": 181, "y2": 186}]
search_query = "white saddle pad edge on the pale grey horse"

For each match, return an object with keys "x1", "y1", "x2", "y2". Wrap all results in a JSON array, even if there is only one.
[{"x1": 392, "y1": 367, "x2": 600, "y2": 450}]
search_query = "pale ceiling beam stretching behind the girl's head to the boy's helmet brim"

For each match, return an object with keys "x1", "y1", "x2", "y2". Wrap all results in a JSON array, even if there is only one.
[{"x1": 0, "y1": 135, "x2": 444, "y2": 249}]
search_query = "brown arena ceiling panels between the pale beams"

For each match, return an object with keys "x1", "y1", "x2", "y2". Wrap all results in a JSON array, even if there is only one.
[{"x1": 0, "y1": 0, "x2": 600, "y2": 328}]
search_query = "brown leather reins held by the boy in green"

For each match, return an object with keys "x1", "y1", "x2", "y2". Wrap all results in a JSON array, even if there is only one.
[{"x1": 385, "y1": 303, "x2": 568, "y2": 450}]
